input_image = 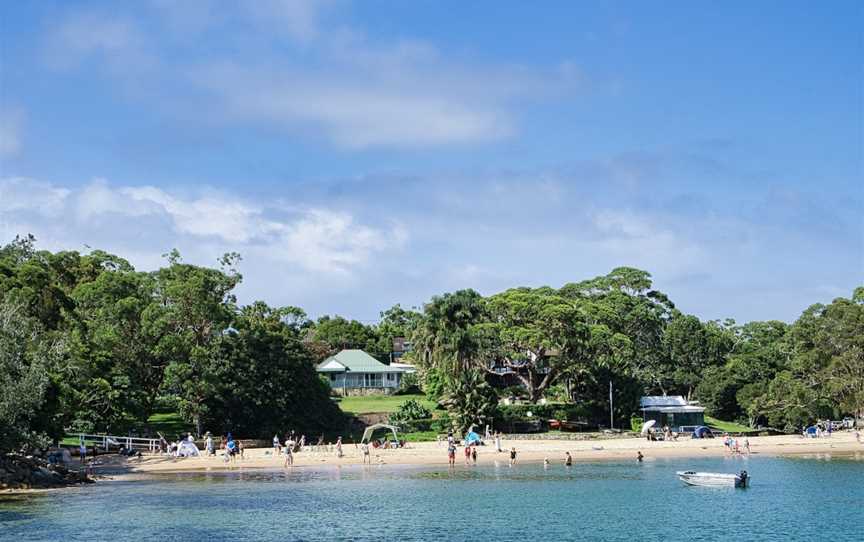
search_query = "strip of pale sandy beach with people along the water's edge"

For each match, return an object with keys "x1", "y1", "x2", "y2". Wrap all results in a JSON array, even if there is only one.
[{"x1": 98, "y1": 433, "x2": 864, "y2": 476}]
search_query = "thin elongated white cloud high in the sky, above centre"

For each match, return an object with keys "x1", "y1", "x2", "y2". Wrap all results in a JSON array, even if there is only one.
[{"x1": 199, "y1": 67, "x2": 514, "y2": 148}]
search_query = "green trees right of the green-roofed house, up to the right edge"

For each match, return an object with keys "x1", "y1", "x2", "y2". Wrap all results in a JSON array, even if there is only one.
[{"x1": 413, "y1": 267, "x2": 864, "y2": 431}]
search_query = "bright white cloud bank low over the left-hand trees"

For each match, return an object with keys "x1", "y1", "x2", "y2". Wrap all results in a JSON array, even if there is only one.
[{"x1": 0, "y1": 178, "x2": 407, "y2": 276}]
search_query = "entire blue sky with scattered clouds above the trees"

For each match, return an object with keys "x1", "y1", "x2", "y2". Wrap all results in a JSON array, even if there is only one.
[{"x1": 0, "y1": 0, "x2": 864, "y2": 321}]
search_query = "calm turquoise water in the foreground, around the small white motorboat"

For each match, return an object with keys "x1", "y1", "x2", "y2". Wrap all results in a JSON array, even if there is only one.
[{"x1": 0, "y1": 456, "x2": 864, "y2": 542}]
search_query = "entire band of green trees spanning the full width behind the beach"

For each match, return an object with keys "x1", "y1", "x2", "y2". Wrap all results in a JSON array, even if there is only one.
[{"x1": 0, "y1": 237, "x2": 864, "y2": 449}]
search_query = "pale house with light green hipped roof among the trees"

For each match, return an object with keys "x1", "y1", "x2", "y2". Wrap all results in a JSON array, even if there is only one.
[{"x1": 316, "y1": 350, "x2": 415, "y2": 395}]
